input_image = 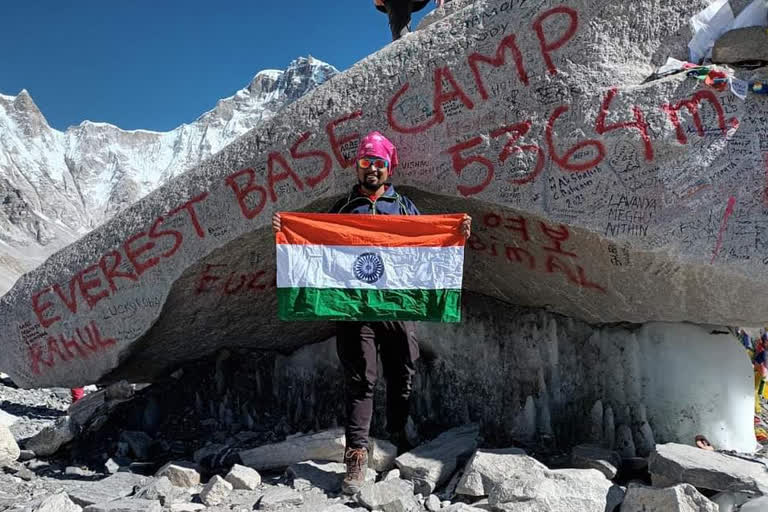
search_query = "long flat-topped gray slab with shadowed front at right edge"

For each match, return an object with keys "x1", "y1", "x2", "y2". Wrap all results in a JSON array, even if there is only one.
[{"x1": 649, "y1": 443, "x2": 768, "y2": 494}]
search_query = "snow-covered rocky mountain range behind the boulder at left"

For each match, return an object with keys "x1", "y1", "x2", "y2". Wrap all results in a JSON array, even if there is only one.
[{"x1": 0, "y1": 56, "x2": 338, "y2": 295}]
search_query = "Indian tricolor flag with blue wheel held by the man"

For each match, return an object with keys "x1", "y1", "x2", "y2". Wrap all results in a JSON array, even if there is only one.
[{"x1": 277, "y1": 213, "x2": 464, "y2": 322}]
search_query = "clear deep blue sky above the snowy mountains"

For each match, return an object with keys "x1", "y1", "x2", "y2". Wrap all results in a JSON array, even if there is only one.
[{"x1": 0, "y1": 0, "x2": 434, "y2": 131}]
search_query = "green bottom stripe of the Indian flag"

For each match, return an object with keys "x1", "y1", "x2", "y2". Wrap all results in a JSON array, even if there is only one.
[{"x1": 277, "y1": 288, "x2": 461, "y2": 322}]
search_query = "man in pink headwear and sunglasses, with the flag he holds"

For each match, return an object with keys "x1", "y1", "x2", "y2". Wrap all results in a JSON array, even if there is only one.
[{"x1": 272, "y1": 131, "x2": 471, "y2": 494}]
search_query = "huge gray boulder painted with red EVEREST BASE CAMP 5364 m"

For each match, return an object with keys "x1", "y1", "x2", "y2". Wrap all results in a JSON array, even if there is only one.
[{"x1": 0, "y1": 0, "x2": 768, "y2": 387}]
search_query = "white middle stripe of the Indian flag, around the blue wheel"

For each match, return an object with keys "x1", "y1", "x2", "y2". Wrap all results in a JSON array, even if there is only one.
[{"x1": 277, "y1": 244, "x2": 464, "y2": 290}]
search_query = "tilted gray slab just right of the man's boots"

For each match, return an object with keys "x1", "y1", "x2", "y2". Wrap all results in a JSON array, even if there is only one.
[{"x1": 395, "y1": 424, "x2": 479, "y2": 494}]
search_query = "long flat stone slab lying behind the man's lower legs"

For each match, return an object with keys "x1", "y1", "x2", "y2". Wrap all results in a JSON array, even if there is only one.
[{"x1": 239, "y1": 428, "x2": 397, "y2": 471}]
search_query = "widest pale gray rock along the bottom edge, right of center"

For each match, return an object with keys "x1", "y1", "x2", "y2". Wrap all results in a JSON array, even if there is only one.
[{"x1": 488, "y1": 469, "x2": 624, "y2": 512}]
